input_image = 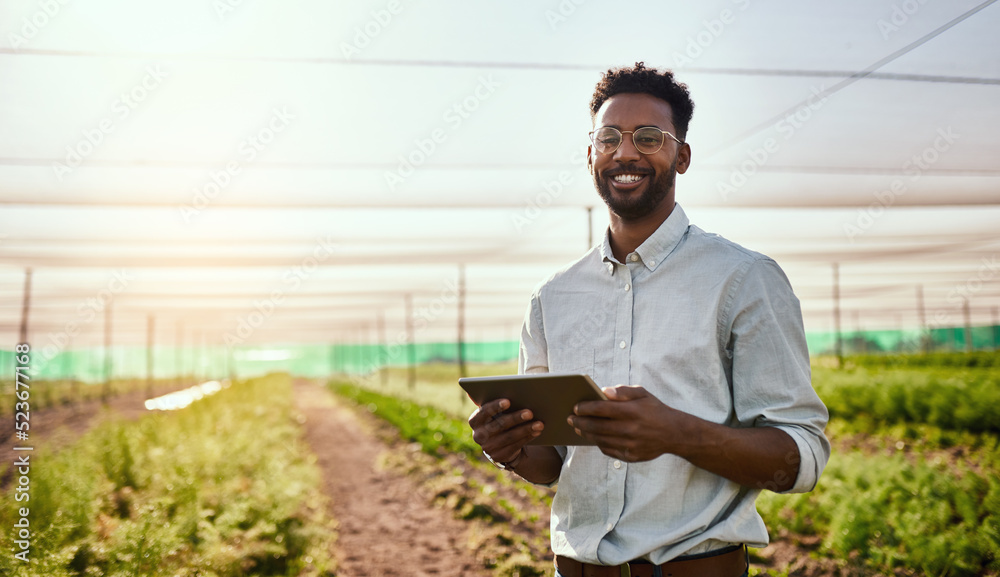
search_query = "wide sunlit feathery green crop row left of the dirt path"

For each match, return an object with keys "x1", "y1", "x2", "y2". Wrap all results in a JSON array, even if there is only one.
[{"x1": 0, "y1": 375, "x2": 334, "y2": 577}]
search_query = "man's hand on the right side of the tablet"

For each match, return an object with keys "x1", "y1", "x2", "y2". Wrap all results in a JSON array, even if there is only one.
[{"x1": 567, "y1": 385, "x2": 676, "y2": 463}]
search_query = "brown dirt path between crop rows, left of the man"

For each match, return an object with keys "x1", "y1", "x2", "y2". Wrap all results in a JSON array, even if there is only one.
[{"x1": 295, "y1": 380, "x2": 489, "y2": 577}]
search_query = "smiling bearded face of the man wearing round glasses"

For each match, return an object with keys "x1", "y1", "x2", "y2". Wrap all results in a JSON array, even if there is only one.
[{"x1": 587, "y1": 93, "x2": 690, "y2": 221}]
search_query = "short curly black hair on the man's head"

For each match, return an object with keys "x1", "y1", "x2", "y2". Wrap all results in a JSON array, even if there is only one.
[{"x1": 590, "y1": 62, "x2": 694, "y2": 140}]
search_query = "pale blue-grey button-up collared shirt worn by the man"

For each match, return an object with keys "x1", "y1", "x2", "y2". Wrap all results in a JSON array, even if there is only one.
[{"x1": 518, "y1": 205, "x2": 830, "y2": 565}]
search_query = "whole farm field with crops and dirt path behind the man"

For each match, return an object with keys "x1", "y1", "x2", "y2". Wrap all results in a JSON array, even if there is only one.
[{"x1": 0, "y1": 360, "x2": 1000, "y2": 577}]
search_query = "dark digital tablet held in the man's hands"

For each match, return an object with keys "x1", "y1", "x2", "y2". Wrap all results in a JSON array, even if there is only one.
[{"x1": 458, "y1": 373, "x2": 607, "y2": 445}]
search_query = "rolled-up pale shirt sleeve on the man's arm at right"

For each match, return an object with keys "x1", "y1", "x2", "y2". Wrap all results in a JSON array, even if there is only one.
[{"x1": 723, "y1": 258, "x2": 830, "y2": 493}]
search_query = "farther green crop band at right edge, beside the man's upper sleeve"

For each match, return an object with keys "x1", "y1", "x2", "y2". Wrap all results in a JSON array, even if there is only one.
[{"x1": 813, "y1": 367, "x2": 1000, "y2": 432}]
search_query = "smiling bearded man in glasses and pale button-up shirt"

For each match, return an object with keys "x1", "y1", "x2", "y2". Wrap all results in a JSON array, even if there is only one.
[{"x1": 469, "y1": 63, "x2": 830, "y2": 577}]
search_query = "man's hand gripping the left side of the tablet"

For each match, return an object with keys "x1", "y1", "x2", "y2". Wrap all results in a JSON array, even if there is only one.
[{"x1": 469, "y1": 399, "x2": 545, "y2": 463}]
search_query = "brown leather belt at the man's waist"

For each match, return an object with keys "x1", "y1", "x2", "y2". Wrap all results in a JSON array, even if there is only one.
[{"x1": 556, "y1": 545, "x2": 747, "y2": 577}]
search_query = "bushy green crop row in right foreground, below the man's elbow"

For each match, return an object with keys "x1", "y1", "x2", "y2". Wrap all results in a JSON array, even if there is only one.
[{"x1": 757, "y1": 452, "x2": 1000, "y2": 576}]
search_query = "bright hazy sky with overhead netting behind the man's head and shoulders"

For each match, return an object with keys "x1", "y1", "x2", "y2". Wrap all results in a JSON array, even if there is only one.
[{"x1": 0, "y1": 0, "x2": 1000, "y2": 354}]
